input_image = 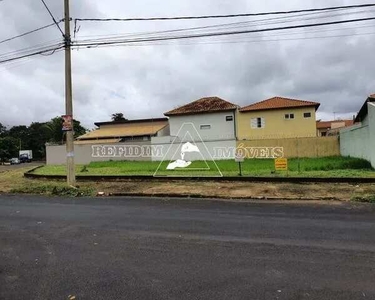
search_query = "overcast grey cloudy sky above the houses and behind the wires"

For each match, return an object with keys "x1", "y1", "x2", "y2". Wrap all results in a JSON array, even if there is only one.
[{"x1": 0, "y1": 0, "x2": 375, "y2": 128}]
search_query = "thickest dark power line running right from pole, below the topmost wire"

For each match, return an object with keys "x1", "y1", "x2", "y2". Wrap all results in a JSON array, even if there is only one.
[{"x1": 75, "y1": 17, "x2": 375, "y2": 47}]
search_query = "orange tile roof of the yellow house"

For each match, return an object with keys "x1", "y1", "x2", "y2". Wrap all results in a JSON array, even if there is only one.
[{"x1": 240, "y1": 97, "x2": 320, "y2": 112}]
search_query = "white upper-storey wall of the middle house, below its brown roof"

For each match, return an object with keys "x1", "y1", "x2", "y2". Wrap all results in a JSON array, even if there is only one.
[{"x1": 169, "y1": 111, "x2": 236, "y2": 141}]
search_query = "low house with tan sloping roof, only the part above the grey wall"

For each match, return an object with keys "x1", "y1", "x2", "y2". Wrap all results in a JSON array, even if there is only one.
[{"x1": 75, "y1": 118, "x2": 169, "y2": 145}]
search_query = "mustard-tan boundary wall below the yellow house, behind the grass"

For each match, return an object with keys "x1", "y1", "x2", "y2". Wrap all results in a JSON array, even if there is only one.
[{"x1": 237, "y1": 136, "x2": 340, "y2": 158}]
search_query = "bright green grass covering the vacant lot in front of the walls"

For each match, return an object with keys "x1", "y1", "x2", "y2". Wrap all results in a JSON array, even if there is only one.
[{"x1": 35, "y1": 156, "x2": 375, "y2": 177}]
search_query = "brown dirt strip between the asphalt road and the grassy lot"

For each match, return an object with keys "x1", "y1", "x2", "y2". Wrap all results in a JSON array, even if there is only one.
[{"x1": 90, "y1": 181, "x2": 375, "y2": 201}]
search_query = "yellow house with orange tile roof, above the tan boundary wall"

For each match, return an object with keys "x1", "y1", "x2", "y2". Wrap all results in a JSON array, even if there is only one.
[{"x1": 238, "y1": 97, "x2": 320, "y2": 140}]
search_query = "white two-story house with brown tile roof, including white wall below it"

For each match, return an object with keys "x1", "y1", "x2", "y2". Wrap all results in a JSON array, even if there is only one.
[{"x1": 151, "y1": 97, "x2": 238, "y2": 160}]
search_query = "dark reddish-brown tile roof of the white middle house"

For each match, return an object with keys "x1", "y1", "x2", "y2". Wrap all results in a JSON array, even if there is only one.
[{"x1": 164, "y1": 97, "x2": 238, "y2": 116}]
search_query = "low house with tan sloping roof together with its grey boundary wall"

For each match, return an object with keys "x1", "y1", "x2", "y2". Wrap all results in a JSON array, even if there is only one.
[{"x1": 46, "y1": 118, "x2": 169, "y2": 165}]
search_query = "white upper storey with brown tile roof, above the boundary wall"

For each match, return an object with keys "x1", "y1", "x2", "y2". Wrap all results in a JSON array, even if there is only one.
[{"x1": 164, "y1": 97, "x2": 238, "y2": 141}]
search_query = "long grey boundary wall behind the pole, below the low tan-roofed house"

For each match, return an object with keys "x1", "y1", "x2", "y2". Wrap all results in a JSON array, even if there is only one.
[{"x1": 46, "y1": 141, "x2": 152, "y2": 165}]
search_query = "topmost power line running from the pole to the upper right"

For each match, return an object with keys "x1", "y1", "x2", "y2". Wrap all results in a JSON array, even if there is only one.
[{"x1": 74, "y1": 0, "x2": 375, "y2": 22}]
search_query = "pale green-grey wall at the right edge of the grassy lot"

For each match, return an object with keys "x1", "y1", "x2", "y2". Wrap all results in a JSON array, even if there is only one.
[{"x1": 340, "y1": 103, "x2": 375, "y2": 168}]
